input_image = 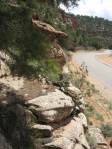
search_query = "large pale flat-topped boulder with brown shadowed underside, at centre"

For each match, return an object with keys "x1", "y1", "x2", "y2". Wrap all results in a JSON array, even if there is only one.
[{"x1": 27, "y1": 89, "x2": 74, "y2": 123}]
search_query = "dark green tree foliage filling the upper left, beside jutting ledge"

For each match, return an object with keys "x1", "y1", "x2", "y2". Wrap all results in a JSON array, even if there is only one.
[{"x1": 0, "y1": 0, "x2": 61, "y2": 80}]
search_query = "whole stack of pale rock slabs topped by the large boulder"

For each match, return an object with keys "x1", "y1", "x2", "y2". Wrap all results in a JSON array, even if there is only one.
[{"x1": 27, "y1": 89, "x2": 89, "y2": 149}]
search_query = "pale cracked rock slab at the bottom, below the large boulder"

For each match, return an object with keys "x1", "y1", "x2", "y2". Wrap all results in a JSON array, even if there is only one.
[{"x1": 46, "y1": 117, "x2": 90, "y2": 149}]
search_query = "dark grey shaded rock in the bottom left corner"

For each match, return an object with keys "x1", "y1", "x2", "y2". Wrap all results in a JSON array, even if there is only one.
[{"x1": 0, "y1": 133, "x2": 13, "y2": 149}]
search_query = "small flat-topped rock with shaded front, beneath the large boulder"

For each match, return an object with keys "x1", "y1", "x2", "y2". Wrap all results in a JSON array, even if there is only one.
[{"x1": 30, "y1": 124, "x2": 53, "y2": 138}]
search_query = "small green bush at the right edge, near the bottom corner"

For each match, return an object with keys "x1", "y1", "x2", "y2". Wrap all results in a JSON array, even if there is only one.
[{"x1": 101, "y1": 124, "x2": 112, "y2": 137}]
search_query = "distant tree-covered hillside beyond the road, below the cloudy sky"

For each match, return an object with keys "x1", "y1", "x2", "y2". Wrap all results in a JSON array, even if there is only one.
[{"x1": 70, "y1": 14, "x2": 112, "y2": 49}]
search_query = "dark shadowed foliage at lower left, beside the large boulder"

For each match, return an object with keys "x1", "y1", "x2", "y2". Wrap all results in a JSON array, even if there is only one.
[{"x1": 0, "y1": 104, "x2": 33, "y2": 149}]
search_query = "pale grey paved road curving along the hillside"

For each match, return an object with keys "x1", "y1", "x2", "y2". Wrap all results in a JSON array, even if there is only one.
[{"x1": 74, "y1": 50, "x2": 112, "y2": 88}]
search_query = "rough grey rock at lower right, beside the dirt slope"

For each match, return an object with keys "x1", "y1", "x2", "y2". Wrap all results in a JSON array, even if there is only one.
[{"x1": 88, "y1": 126, "x2": 107, "y2": 147}]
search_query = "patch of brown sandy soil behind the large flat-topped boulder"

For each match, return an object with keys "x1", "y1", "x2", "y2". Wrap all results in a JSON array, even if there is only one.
[{"x1": 0, "y1": 76, "x2": 55, "y2": 100}]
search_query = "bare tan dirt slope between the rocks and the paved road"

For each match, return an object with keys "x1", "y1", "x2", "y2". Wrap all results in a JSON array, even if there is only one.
[{"x1": 69, "y1": 53, "x2": 112, "y2": 126}]
